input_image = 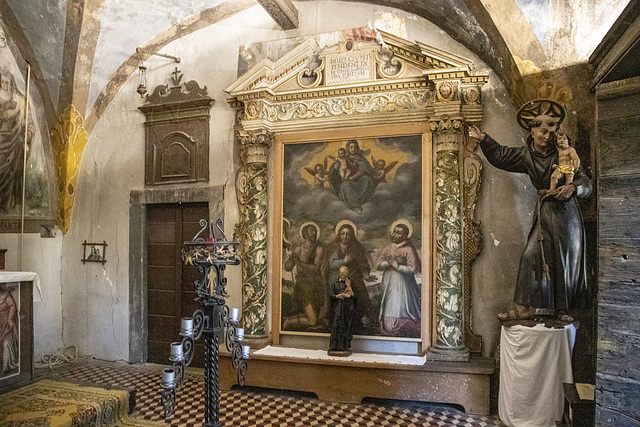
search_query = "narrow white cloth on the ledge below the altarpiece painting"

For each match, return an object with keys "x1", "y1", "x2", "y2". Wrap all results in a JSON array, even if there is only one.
[{"x1": 253, "y1": 345, "x2": 426, "y2": 365}]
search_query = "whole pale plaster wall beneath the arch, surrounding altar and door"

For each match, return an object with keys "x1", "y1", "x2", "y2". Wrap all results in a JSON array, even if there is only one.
[{"x1": 61, "y1": 2, "x2": 533, "y2": 359}]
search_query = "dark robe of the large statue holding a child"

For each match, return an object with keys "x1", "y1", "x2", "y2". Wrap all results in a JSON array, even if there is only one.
[{"x1": 480, "y1": 135, "x2": 591, "y2": 310}]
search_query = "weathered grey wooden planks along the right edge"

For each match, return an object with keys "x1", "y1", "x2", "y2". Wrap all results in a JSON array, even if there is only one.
[{"x1": 596, "y1": 79, "x2": 640, "y2": 426}]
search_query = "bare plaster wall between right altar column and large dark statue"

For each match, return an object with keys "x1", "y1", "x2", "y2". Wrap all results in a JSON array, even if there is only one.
[{"x1": 472, "y1": 85, "x2": 536, "y2": 356}]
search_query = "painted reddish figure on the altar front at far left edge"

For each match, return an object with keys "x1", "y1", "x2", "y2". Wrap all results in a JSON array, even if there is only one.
[{"x1": 0, "y1": 283, "x2": 20, "y2": 375}]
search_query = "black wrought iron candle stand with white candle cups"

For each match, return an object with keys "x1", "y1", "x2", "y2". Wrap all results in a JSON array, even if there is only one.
[{"x1": 161, "y1": 219, "x2": 249, "y2": 427}]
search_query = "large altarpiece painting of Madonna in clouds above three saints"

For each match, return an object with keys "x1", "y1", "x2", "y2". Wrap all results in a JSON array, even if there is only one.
[{"x1": 281, "y1": 135, "x2": 422, "y2": 338}]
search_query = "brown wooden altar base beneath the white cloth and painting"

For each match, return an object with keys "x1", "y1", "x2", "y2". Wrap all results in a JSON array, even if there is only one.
[{"x1": 220, "y1": 354, "x2": 494, "y2": 415}]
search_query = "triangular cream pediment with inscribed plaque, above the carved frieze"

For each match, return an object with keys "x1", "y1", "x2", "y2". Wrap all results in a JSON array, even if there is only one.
[{"x1": 226, "y1": 30, "x2": 486, "y2": 98}]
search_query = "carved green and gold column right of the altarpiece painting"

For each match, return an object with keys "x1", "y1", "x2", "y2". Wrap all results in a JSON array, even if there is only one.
[{"x1": 427, "y1": 116, "x2": 469, "y2": 361}]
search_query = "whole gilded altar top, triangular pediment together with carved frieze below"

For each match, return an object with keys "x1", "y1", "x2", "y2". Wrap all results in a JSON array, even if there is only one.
[{"x1": 226, "y1": 30, "x2": 488, "y2": 129}]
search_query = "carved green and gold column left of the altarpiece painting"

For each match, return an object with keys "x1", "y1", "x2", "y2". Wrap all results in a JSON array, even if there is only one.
[{"x1": 236, "y1": 130, "x2": 274, "y2": 342}]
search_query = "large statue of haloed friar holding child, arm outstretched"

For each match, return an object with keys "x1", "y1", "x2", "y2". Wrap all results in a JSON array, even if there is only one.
[{"x1": 469, "y1": 99, "x2": 591, "y2": 324}]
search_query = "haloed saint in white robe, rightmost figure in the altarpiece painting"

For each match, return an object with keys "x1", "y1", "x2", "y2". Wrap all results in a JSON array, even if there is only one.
[{"x1": 376, "y1": 220, "x2": 421, "y2": 337}]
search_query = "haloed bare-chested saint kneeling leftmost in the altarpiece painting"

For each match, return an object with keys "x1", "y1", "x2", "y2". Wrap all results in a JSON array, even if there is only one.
[{"x1": 282, "y1": 222, "x2": 328, "y2": 330}]
